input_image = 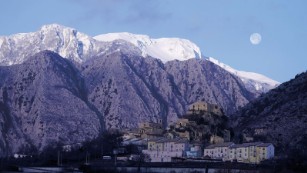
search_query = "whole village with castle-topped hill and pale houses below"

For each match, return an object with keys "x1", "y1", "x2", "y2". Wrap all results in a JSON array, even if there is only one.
[{"x1": 123, "y1": 102, "x2": 274, "y2": 164}]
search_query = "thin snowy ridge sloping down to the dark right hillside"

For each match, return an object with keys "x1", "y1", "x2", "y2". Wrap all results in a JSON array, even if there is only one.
[{"x1": 207, "y1": 57, "x2": 280, "y2": 92}]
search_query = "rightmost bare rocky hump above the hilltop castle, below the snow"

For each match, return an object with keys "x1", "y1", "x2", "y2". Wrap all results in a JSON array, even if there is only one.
[{"x1": 165, "y1": 59, "x2": 255, "y2": 115}]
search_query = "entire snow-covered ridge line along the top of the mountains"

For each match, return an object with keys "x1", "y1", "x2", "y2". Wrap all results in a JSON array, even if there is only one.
[{"x1": 0, "y1": 24, "x2": 280, "y2": 93}]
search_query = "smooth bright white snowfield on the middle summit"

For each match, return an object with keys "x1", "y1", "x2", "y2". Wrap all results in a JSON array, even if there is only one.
[{"x1": 94, "y1": 32, "x2": 201, "y2": 62}]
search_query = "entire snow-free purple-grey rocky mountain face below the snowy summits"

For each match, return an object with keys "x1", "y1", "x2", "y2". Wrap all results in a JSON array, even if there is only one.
[{"x1": 0, "y1": 49, "x2": 254, "y2": 155}]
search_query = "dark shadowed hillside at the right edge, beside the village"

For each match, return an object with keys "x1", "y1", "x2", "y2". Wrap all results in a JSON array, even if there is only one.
[{"x1": 233, "y1": 72, "x2": 307, "y2": 157}]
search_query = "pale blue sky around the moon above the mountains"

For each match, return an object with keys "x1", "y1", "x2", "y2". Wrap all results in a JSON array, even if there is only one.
[{"x1": 0, "y1": 0, "x2": 307, "y2": 82}]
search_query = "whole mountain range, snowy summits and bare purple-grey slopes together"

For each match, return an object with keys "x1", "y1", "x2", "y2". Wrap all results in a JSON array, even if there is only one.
[{"x1": 0, "y1": 24, "x2": 278, "y2": 155}]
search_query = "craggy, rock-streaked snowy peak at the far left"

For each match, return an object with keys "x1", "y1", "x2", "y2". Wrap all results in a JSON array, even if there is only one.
[{"x1": 0, "y1": 24, "x2": 105, "y2": 65}]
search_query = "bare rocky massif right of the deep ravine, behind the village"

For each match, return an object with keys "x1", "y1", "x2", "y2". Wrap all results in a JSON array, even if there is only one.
[{"x1": 82, "y1": 52, "x2": 254, "y2": 128}]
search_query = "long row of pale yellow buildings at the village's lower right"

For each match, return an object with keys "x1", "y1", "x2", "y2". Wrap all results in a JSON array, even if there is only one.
[{"x1": 204, "y1": 142, "x2": 274, "y2": 163}]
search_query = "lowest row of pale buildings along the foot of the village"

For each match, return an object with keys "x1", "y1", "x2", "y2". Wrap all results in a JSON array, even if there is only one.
[{"x1": 142, "y1": 138, "x2": 274, "y2": 164}]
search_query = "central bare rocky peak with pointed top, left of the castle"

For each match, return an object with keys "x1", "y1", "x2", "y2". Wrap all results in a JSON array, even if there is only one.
[{"x1": 82, "y1": 52, "x2": 185, "y2": 128}]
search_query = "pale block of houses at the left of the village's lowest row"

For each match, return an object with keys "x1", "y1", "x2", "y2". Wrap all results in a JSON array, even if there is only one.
[{"x1": 143, "y1": 138, "x2": 189, "y2": 162}]
